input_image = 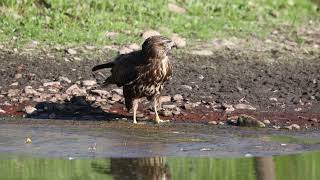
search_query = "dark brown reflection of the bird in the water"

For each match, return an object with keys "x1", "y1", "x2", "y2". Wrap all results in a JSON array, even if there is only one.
[{"x1": 92, "y1": 157, "x2": 171, "y2": 180}]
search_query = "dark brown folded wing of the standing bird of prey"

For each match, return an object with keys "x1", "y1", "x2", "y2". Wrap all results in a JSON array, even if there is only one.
[{"x1": 111, "y1": 51, "x2": 148, "y2": 86}]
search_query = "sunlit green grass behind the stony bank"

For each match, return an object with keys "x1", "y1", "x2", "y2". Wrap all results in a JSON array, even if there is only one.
[{"x1": 0, "y1": 0, "x2": 320, "y2": 45}]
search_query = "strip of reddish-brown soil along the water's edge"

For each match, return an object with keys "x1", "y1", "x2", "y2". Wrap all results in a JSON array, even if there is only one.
[{"x1": 0, "y1": 101, "x2": 320, "y2": 129}]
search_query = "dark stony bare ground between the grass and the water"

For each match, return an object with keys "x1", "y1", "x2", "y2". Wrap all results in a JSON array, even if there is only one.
[{"x1": 0, "y1": 27, "x2": 320, "y2": 129}]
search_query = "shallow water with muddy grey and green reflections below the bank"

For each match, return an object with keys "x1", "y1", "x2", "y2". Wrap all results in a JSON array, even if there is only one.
[{"x1": 0, "y1": 122, "x2": 320, "y2": 180}]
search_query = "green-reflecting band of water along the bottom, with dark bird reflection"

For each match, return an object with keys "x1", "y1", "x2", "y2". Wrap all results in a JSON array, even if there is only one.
[{"x1": 0, "y1": 152, "x2": 320, "y2": 180}]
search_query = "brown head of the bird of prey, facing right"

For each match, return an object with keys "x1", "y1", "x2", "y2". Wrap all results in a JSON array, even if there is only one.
[{"x1": 142, "y1": 36, "x2": 176, "y2": 58}]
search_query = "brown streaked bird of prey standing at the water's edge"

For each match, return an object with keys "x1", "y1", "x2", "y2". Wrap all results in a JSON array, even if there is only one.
[{"x1": 92, "y1": 36, "x2": 176, "y2": 124}]
